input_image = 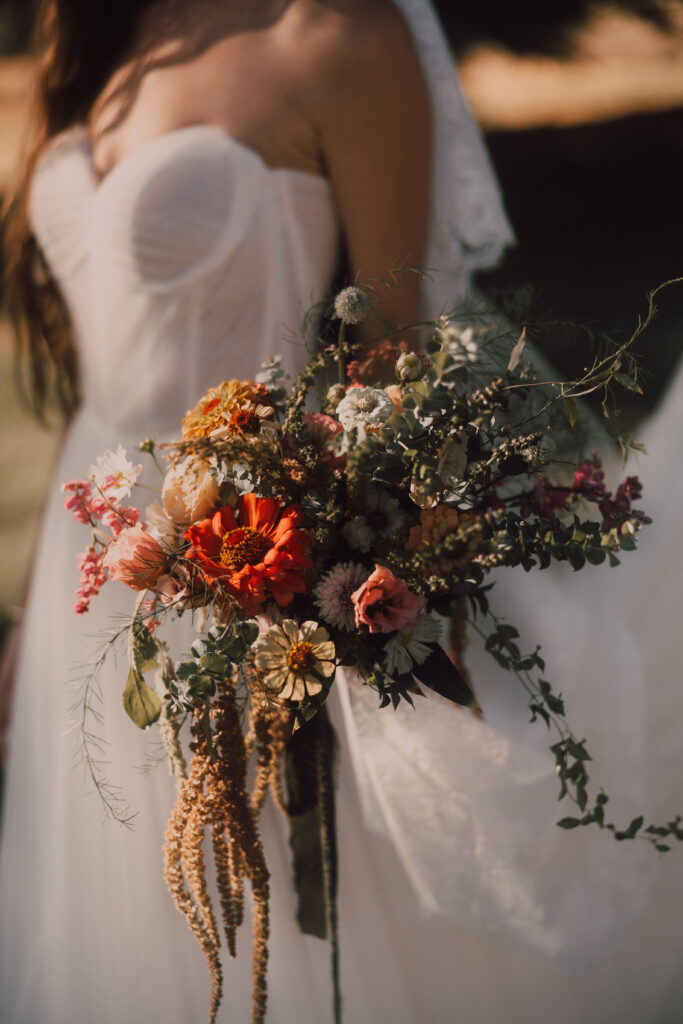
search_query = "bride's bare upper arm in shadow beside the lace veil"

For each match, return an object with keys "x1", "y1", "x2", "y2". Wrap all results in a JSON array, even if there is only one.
[{"x1": 307, "y1": 0, "x2": 432, "y2": 338}]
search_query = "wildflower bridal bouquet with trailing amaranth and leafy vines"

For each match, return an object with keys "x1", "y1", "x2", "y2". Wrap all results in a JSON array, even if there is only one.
[{"x1": 65, "y1": 288, "x2": 679, "y2": 1021}]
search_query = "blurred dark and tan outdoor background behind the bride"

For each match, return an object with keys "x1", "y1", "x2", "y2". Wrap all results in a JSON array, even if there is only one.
[{"x1": 0, "y1": 0, "x2": 683, "y2": 625}]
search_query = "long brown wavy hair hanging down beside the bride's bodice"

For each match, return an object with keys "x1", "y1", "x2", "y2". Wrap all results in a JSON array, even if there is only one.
[{"x1": 4, "y1": 0, "x2": 154, "y2": 414}]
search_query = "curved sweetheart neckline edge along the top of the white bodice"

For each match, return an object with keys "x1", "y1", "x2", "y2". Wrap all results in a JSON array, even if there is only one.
[{"x1": 38, "y1": 123, "x2": 332, "y2": 195}]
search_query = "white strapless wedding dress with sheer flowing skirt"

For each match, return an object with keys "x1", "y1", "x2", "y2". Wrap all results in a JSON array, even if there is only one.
[{"x1": 0, "y1": 4, "x2": 683, "y2": 1024}]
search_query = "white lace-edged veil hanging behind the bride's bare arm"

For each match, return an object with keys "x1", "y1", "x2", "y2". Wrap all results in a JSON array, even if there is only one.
[{"x1": 395, "y1": 0, "x2": 515, "y2": 315}]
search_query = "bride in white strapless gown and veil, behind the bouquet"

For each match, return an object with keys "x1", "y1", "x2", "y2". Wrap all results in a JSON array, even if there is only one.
[{"x1": 0, "y1": 0, "x2": 683, "y2": 1024}]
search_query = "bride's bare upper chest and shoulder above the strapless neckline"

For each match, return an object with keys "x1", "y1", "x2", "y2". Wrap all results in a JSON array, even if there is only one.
[{"x1": 88, "y1": 0, "x2": 398, "y2": 186}]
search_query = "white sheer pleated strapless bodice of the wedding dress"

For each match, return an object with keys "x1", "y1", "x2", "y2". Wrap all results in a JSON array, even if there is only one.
[{"x1": 30, "y1": 125, "x2": 339, "y2": 435}]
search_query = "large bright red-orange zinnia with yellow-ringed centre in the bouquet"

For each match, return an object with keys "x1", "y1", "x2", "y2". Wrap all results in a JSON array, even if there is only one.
[{"x1": 184, "y1": 495, "x2": 312, "y2": 614}]
